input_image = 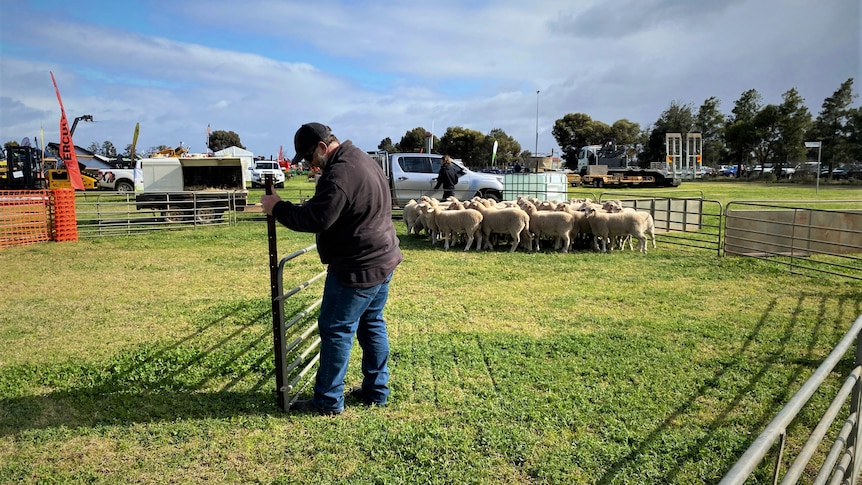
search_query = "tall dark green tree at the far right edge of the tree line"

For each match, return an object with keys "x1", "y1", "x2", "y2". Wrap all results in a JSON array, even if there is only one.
[{"x1": 813, "y1": 78, "x2": 856, "y2": 176}]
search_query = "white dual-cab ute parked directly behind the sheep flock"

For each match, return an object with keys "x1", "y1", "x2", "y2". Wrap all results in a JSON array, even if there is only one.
[{"x1": 369, "y1": 152, "x2": 503, "y2": 207}]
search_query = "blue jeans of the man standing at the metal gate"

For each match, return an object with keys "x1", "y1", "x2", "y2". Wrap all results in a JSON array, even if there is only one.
[{"x1": 312, "y1": 273, "x2": 392, "y2": 412}]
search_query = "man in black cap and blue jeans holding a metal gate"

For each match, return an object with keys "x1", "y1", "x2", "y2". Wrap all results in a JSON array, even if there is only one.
[{"x1": 261, "y1": 123, "x2": 402, "y2": 414}]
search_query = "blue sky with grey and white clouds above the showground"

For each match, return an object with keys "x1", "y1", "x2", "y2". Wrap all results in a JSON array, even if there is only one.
[{"x1": 0, "y1": 0, "x2": 862, "y2": 157}]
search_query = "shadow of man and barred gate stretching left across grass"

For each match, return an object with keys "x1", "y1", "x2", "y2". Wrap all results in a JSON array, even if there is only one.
[{"x1": 0, "y1": 302, "x2": 282, "y2": 436}]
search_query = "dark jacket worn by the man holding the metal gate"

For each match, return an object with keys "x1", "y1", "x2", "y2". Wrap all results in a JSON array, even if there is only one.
[{"x1": 272, "y1": 140, "x2": 402, "y2": 287}]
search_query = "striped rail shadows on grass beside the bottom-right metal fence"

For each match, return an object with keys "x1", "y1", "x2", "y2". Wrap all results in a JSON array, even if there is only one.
[{"x1": 596, "y1": 295, "x2": 860, "y2": 484}]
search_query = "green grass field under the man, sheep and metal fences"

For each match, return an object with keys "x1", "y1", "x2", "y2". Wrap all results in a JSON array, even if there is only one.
[{"x1": 0, "y1": 181, "x2": 862, "y2": 484}]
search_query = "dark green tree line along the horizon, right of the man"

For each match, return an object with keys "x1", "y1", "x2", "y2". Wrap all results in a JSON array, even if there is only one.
[{"x1": 378, "y1": 78, "x2": 862, "y2": 172}]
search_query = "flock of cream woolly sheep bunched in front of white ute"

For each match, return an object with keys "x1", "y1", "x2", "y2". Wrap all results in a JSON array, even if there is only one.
[{"x1": 403, "y1": 196, "x2": 656, "y2": 253}]
